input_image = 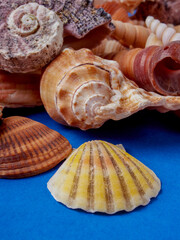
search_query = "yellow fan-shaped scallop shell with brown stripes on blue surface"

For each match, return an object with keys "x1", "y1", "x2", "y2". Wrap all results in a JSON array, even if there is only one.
[{"x1": 47, "y1": 140, "x2": 161, "y2": 214}]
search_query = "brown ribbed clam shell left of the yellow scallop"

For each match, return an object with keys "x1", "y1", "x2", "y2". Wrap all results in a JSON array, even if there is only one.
[{"x1": 0, "y1": 117, "x2": 72, "y2": 178}]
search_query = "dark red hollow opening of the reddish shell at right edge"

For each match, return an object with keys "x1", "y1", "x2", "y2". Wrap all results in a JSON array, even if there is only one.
[{"x1": 154, "y1": 57, "x2": 180, "y2": 95}]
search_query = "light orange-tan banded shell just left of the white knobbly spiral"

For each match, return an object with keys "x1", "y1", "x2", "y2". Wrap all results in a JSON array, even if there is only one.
[{"x1": 112, "y1": 20, "x2": 150, "y2": 48}]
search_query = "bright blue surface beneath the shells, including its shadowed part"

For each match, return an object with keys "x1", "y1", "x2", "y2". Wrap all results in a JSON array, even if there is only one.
[{"x1": 0, "y1": 108, "x2": 180, "y2": 240}]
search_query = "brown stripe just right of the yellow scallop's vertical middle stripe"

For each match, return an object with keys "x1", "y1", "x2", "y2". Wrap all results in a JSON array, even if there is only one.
[{"x1": 95, "y1": 141, "x2": 114, "y2": 213}]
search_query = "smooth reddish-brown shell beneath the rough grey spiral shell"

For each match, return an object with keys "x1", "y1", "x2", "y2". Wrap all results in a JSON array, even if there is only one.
[{"x1": 0, "y1": 71, "x2": 42, "y2": 108}]
